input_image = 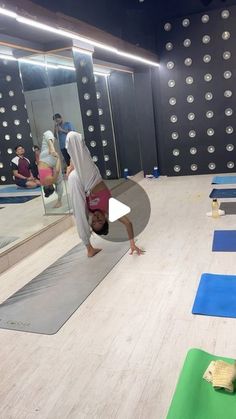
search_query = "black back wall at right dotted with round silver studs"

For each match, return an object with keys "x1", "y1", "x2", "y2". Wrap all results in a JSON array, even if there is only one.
[{"x1": 157, "y1": 6, "x2": 236, "y2": 175}]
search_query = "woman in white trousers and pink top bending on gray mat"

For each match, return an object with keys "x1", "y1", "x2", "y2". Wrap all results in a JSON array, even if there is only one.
[{"x1": 66, "y1": 131, "x2": 142, "y2": 257}]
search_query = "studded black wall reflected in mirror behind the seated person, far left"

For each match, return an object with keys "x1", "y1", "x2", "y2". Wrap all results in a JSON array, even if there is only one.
[{"x1": 0, "y1": 60, "x2": 33, "y2": 184}]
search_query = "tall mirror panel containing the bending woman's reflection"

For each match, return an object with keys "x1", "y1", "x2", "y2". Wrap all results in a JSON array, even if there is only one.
[{"x1": 20, "y1": 55, "x2": 79, "y2": 214}]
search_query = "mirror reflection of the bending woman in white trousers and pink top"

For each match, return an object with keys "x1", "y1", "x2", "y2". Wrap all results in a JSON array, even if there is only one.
[{"x1": 38, "y1": 130, "x2": 63, "y2": 208}]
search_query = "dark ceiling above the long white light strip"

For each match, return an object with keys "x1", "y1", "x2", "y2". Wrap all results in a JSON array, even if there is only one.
[{"x1": 32, "y1": 0, "x2": 236, "y2": 52}]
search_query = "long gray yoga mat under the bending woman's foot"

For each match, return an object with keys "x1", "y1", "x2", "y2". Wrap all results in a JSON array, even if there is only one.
[{"x1": 0, "y1": 240, "x2": 129, "y2": 335}]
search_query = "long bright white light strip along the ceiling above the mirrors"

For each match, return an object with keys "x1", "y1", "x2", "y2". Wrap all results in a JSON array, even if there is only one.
[{"x1": 0, "y1": 8, "x2": 159, "y2": 67}]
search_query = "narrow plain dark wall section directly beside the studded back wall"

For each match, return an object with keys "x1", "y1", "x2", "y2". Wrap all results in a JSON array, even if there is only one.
[{"x1": 134, "y1": 68, "x2": 158, "y2": 174}]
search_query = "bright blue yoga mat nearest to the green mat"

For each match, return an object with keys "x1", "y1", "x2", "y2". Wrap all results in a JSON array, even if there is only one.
[{"x1": 192, "y1": 273, "x2": 236, "y2": 318}]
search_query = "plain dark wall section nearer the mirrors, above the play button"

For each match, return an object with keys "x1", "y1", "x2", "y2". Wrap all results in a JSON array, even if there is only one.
[{"x1": 108, "y1": 71, "x2": 142, "y2": 176}]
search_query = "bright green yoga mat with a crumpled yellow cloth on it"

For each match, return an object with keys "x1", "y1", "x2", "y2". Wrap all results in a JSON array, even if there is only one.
[{"x1": 166, "y1": 349, "x2": 236, "y2": 419}]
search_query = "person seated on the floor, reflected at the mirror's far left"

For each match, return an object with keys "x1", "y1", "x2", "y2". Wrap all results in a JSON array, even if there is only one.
[{"x1": 11, "y1": 144, "x2": 40, "y2": 188}]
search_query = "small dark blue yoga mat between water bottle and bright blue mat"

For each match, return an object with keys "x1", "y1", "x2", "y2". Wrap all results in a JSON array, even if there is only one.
[{"x1": 212, "y1": 230, "x2": 236, "y2": 252}]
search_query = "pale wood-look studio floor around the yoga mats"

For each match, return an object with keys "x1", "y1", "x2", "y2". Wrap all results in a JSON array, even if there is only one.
[{"x1": 0, "y1": 175, "x2": 236, "y2": 419}]
